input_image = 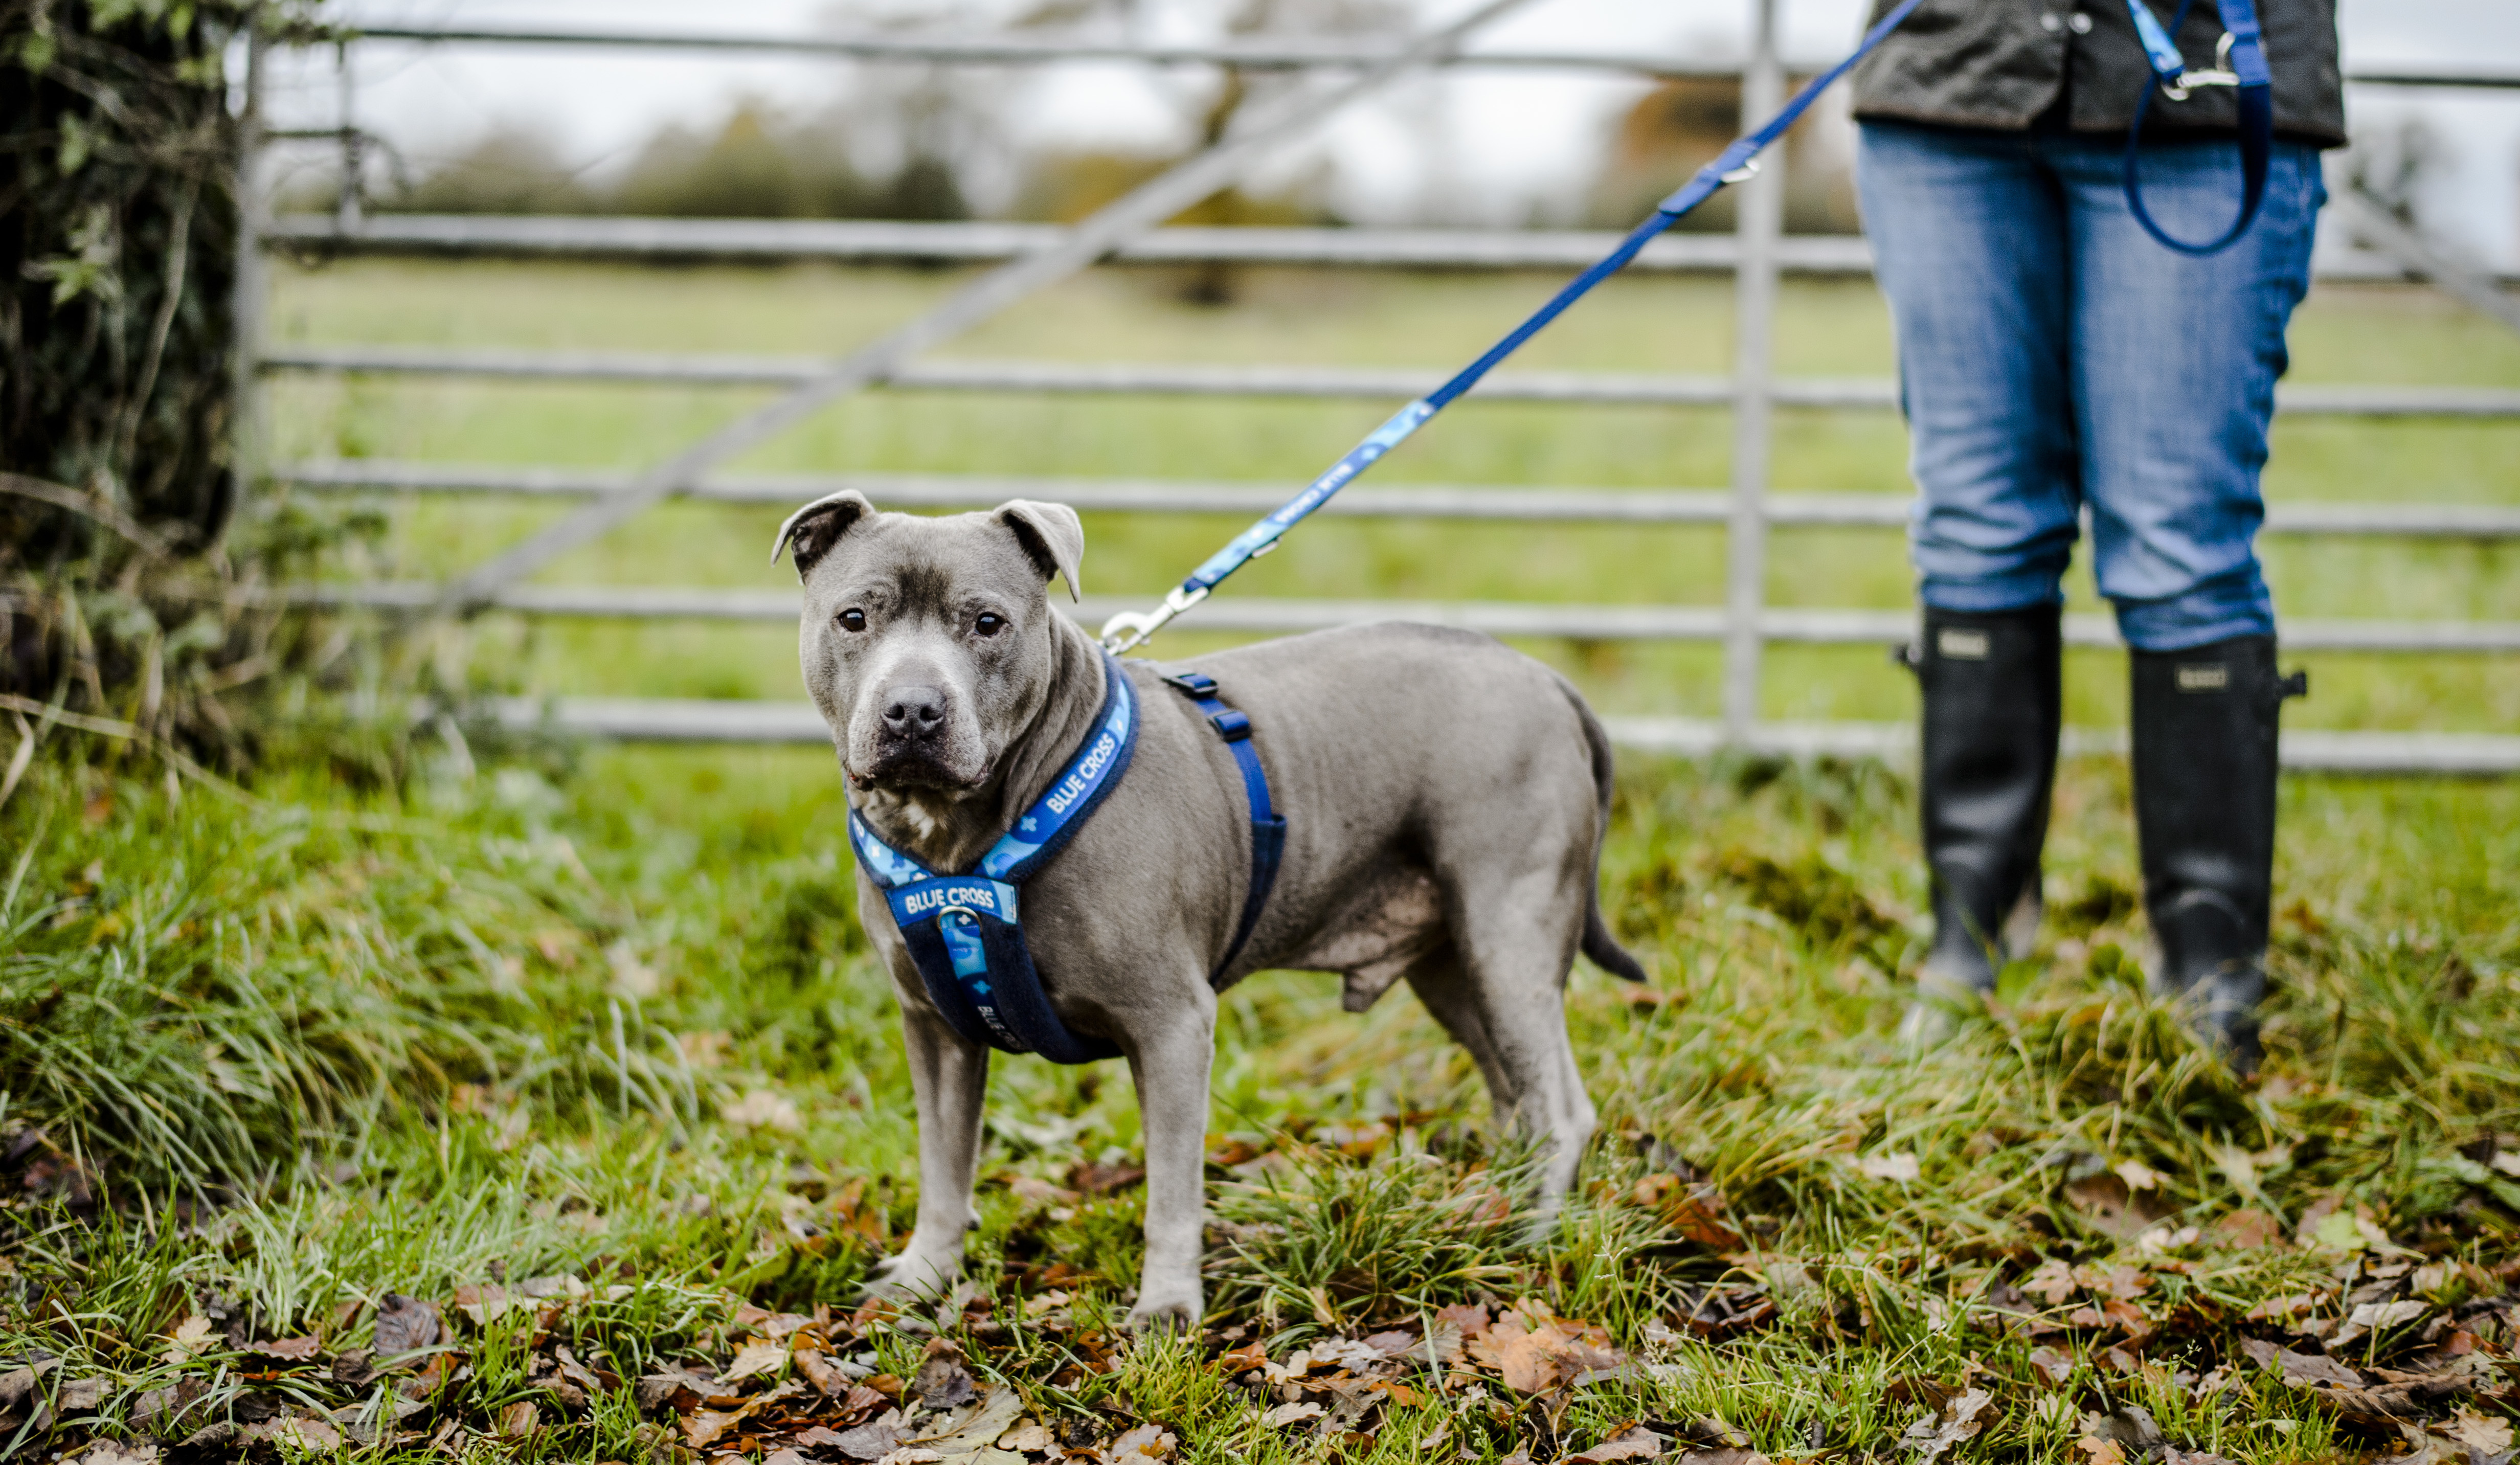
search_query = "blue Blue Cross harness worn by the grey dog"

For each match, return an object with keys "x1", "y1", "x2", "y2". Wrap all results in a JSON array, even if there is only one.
[{"x1": 849, "y1": 653, "x2": 1285, "y2": 1064}]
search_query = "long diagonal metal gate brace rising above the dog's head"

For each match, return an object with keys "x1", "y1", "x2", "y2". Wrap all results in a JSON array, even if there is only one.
[{"x1": 431, "y1": 0, "x2": 1527, "y2": 615}]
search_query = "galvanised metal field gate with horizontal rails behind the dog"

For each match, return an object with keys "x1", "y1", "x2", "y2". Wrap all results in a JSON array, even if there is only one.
[{"x1": 239, "y1": 0, "x2": 2520, "y2": 774}]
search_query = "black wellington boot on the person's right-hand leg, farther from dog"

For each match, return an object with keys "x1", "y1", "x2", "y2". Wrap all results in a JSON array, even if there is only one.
[{"x1": 2129, "y1": 636, "x2": 2308, "y2": 1074}]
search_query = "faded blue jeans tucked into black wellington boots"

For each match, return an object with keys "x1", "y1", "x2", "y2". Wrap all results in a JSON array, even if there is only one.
[{"x1": 1855, "y1": 121, "x2": 2326, "y2": 650}]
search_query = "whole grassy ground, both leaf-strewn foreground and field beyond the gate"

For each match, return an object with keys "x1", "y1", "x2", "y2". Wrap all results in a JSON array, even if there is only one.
[{"x1": 0, "y1": 265, "x2": 2520, "y2": 1465}]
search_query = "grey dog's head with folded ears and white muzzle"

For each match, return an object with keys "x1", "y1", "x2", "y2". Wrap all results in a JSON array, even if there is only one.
[{"x1": 771, "y1": 492, "x2": 1086, "y2": 797}]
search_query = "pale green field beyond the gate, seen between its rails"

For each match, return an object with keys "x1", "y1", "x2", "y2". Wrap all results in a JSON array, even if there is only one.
[{"x1": 275, "y1": 262, "x2": 2520, "y2": 731}]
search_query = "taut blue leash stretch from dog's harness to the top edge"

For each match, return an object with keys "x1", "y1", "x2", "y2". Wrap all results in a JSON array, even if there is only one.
[{"x1": 1101, "y1": 0, "x2": 1935, "y2": 650}]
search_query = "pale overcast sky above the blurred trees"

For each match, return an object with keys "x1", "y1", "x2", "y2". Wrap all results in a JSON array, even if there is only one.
[{"x1": 256, "y1": 0, "x2": 2520, "y2": 267}]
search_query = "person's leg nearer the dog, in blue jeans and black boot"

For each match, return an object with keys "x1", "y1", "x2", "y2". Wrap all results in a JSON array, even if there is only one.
[{"x1": 1855, "y1": 124, "x2": 2082, "y2": 1019}]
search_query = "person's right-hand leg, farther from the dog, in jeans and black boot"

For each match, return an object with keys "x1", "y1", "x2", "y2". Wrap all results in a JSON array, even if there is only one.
[{"x1": 2049, "y1": 139, "x2": 2326, "y2": 1067}]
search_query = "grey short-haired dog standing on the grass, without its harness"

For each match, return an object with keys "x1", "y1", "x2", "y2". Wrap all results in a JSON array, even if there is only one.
[{"x1": 774, "y1": 492, "x2": 1646, "y2": 1326}]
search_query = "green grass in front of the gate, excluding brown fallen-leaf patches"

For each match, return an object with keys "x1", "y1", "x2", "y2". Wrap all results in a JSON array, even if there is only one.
[{"x1": 0, "y1": 741, "x2": 2520, "y2": 1465}]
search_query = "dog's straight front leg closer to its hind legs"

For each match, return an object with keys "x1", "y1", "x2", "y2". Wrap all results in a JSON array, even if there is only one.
[{"x1": 1129, "y1": 983, "x2": 1217, "y2": 1332}]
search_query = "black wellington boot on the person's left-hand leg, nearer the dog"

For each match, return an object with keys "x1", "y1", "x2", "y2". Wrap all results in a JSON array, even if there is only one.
[{"x1": 1903, "y1": 605, "x2": 2061, "y2": 1039}]
